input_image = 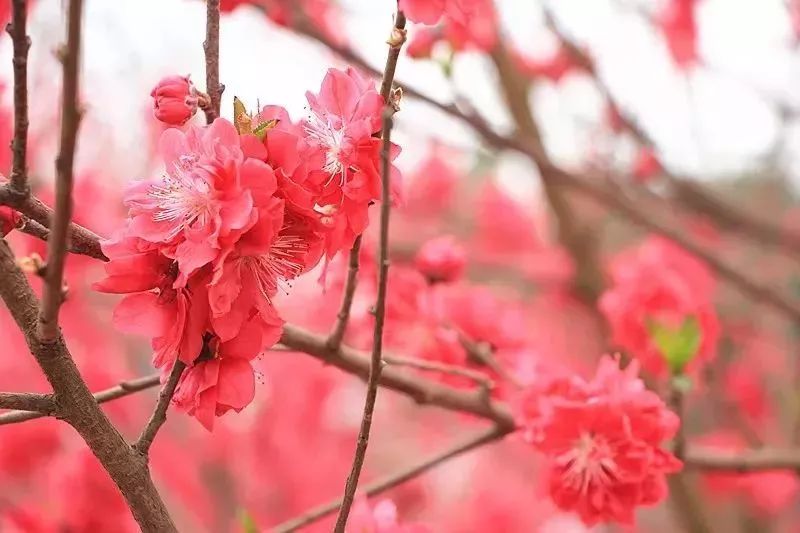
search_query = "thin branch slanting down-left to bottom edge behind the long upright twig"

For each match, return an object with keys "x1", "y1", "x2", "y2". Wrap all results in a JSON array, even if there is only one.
[{"x1": 270, "y1": 428, "x2": 509, "y2": 533}]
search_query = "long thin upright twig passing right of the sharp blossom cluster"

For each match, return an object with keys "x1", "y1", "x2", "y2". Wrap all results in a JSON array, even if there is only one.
[{"x1": 334, "y1": 10, "x2": 406, "y2": 533}]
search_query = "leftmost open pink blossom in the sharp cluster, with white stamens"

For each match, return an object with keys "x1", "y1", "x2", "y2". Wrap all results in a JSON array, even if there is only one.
[{"x1": 125, "y1": 119, "x2": 254, "y2": 285}]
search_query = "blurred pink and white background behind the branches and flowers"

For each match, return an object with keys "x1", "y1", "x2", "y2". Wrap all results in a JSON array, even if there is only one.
[{"x1": 0, "y1": 0, "x2": 800, "y2": 533}]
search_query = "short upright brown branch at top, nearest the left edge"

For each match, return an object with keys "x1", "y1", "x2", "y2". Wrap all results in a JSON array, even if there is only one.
[{"x1": 6, "y1": 0, "x2": 31, "y2": 200}]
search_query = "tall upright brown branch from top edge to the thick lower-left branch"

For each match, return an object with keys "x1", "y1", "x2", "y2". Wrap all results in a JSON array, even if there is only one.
[{"x1": 39, "y1": 0, "x2": 83, "y2": 342}]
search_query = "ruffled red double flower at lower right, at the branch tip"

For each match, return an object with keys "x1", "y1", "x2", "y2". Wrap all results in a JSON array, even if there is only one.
[{"x1": 518, "y1": 356, "x2": 681, "y2": 525}]
